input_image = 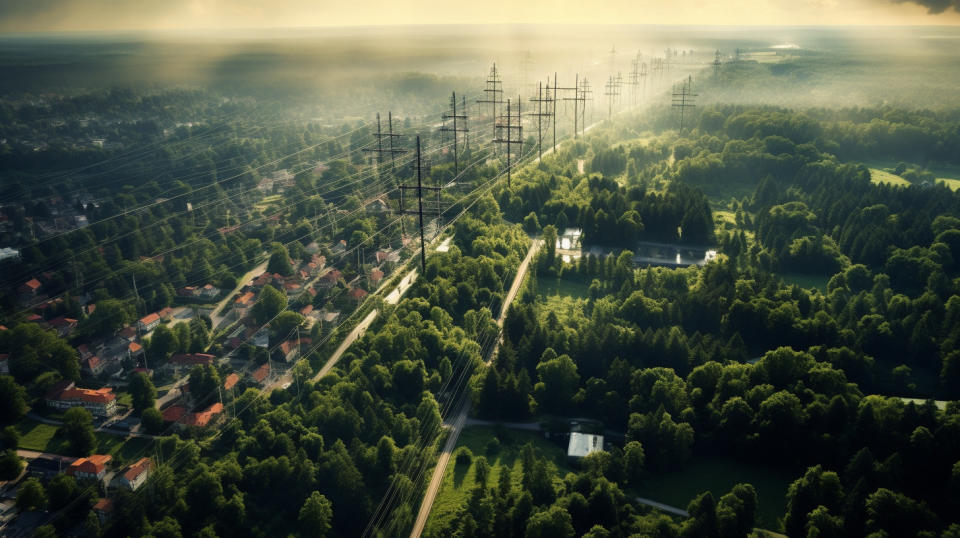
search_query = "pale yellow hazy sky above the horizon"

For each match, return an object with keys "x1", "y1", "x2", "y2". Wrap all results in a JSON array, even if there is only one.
[{"x1": 0, "y1": 0, "x2": 960, "y2": 32}]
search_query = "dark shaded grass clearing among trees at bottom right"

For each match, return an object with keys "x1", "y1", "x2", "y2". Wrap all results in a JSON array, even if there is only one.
[{"x1": 633, "y1": 457, "x2": 799, "y2": 530}]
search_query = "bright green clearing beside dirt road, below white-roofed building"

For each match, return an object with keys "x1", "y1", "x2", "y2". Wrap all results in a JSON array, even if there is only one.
[{"x1": 424, "y1": 426, "x2": 571, "y2": 536}]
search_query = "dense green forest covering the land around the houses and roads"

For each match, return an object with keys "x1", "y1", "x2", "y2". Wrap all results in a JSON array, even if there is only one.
[{"x1": 0, "y1": 53, "x2": 960, "y2": 537}]
